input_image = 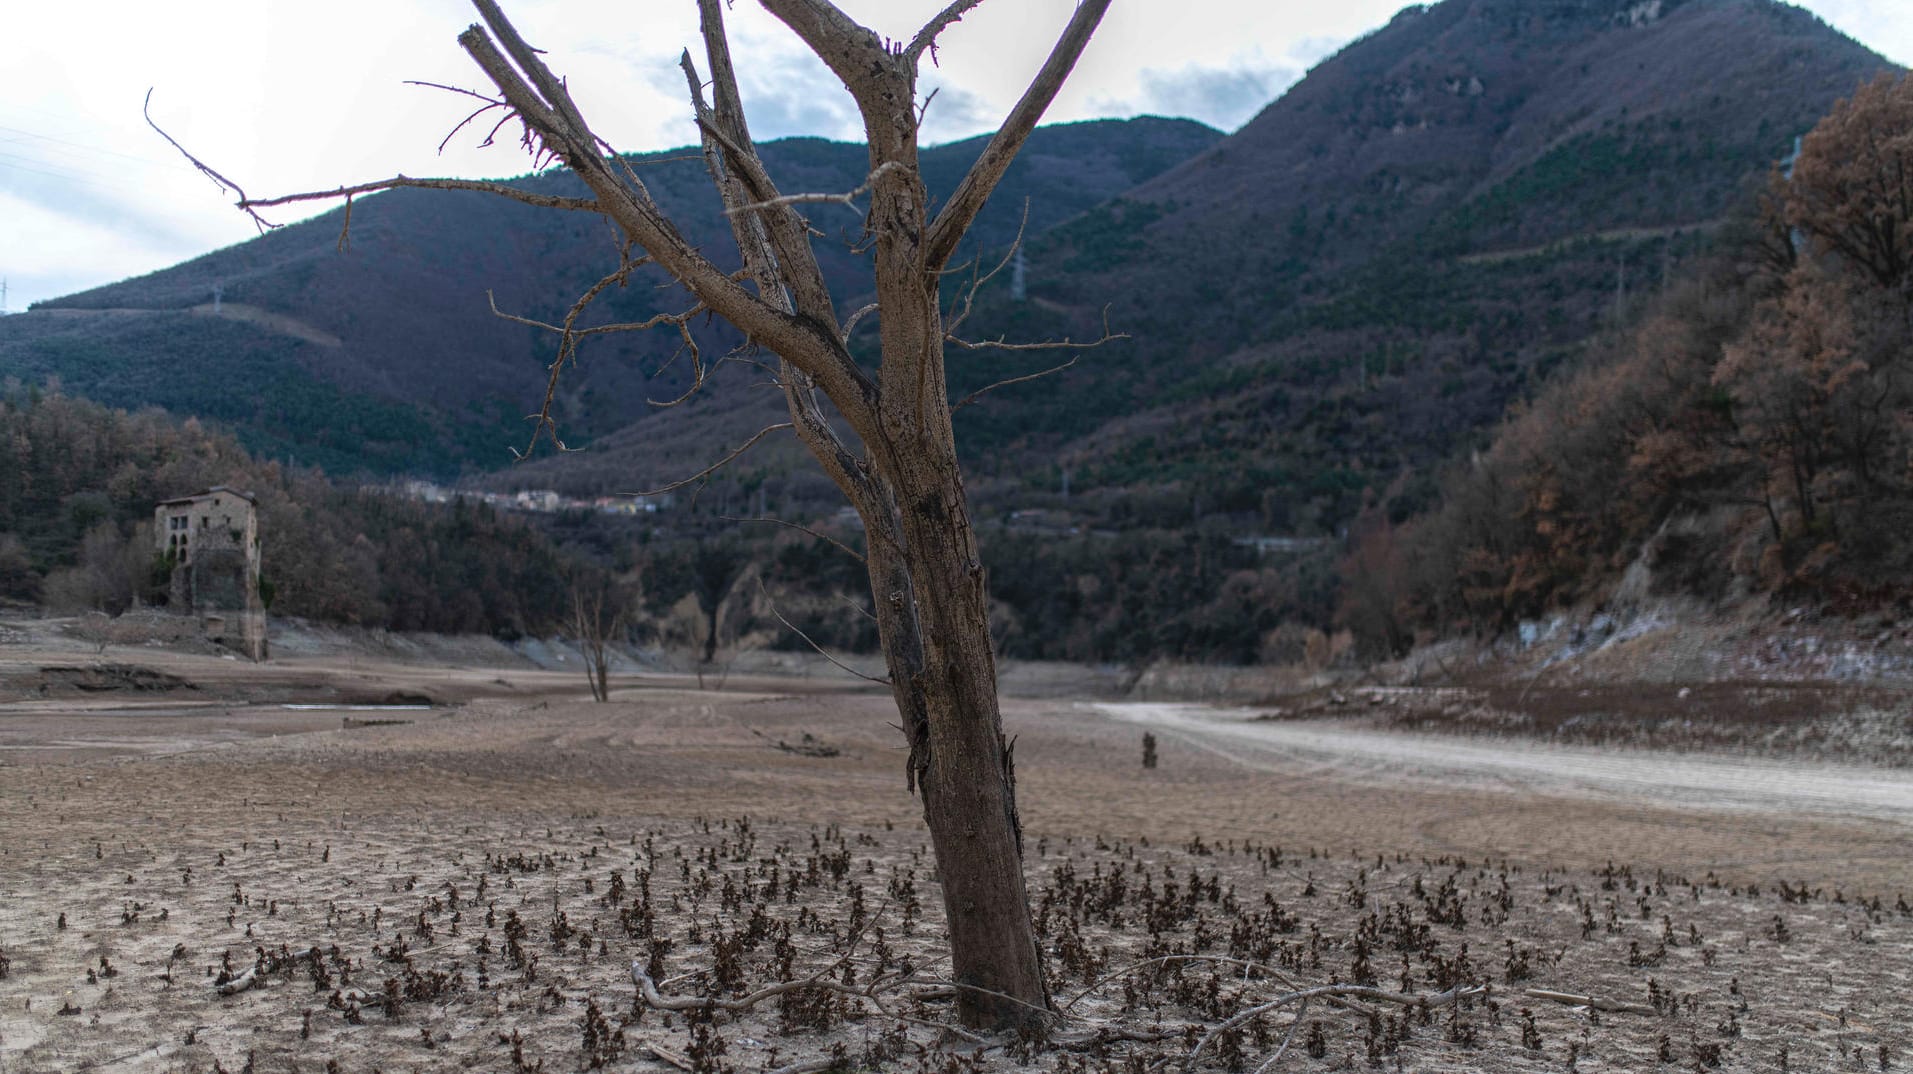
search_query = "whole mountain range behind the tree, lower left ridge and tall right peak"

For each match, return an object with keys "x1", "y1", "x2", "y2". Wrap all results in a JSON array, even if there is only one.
[{"x1": 0, "y1": 0, "x2": 1890, "y2": 536}]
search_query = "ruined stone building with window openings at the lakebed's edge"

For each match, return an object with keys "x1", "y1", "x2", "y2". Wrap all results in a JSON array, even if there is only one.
[{"x1": 153, "y1": 484, "x2": 266, "y2": 660}]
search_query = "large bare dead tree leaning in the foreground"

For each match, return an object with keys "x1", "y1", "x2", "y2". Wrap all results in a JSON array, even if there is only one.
[{"x1": 205, "y1": 0, "x2": 1110, "y2": 1026}]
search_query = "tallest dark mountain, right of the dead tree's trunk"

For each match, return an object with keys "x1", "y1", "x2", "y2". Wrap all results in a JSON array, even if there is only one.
[{"x1": 993, "y1": 0, "x2": 1888, "y2": 528}]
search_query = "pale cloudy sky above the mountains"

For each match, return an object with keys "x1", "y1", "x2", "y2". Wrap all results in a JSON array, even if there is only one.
[{"x1": 0, "y1": 0, "x2": 1913, "y2": 312}]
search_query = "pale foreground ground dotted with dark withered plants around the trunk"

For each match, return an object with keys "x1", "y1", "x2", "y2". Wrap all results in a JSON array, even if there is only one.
[{"x1": 0, "y1": 804, "x2": 1913, "y2": 1074}]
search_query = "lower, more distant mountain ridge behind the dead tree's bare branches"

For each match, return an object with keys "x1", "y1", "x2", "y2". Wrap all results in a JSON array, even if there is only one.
[{"x1": 0, "y1": 119, "x2": 1220, "y2": 475}]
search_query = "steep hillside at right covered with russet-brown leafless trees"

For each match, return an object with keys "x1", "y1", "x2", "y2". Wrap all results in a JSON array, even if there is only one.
[{"x1": 1385, "y1": 77, "x2": 1913, "y2": 632}]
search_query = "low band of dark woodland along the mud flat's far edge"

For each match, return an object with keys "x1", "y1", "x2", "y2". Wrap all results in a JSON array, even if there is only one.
[{"x1": 0, "y1": 381, "x2": 1333, "y2": 662}]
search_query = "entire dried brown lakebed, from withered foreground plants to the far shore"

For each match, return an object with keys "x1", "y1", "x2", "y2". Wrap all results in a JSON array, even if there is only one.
[{"x1": 0, "y1": 631, "x2": 1913, "y2": 1074}]
